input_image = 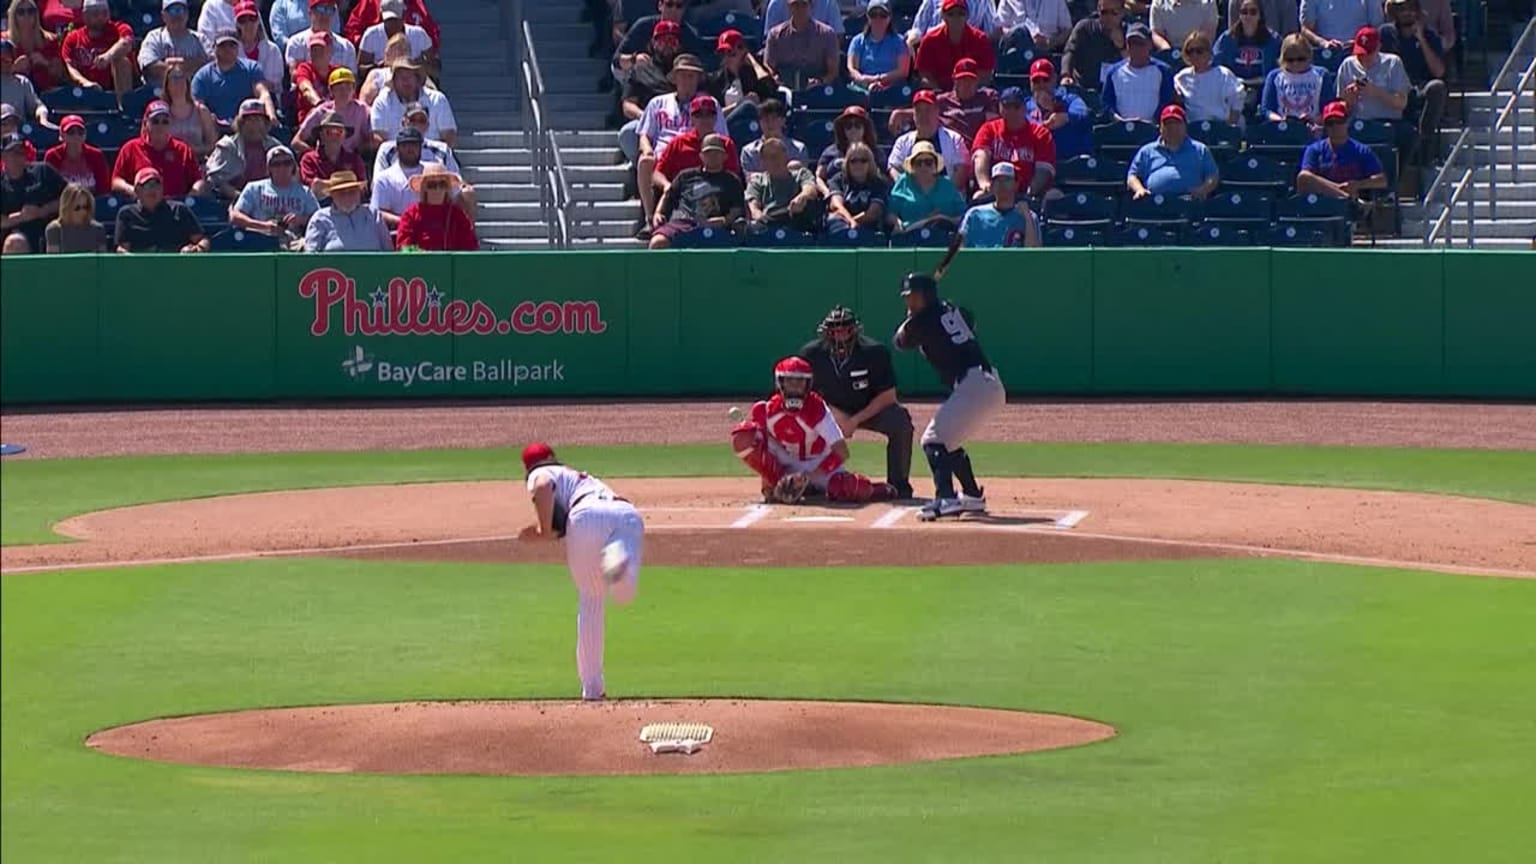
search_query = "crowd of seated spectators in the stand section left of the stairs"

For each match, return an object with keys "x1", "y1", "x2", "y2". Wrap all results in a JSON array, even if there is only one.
[{"x1": 0, "y1": 0, "x2": 479, "y2": 255}]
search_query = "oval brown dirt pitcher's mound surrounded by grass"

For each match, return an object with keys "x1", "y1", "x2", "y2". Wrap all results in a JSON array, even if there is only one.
[{"x1": 86, "y1": 700, "x2": 1115, "y2": 775}]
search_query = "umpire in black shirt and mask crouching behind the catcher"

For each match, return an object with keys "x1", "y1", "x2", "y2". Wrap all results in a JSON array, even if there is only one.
[{"x1": 800, "y1": 306, "x2": 912, "y2": 498}]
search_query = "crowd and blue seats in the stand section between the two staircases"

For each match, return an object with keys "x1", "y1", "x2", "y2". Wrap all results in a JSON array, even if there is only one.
[{"x1": 588, "y1": 0, "x2": 1459, "y2": 249}]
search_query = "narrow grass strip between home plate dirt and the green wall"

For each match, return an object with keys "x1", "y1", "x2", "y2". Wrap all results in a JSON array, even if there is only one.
[{"x1": 0, "y1": 443, "x2": 1536, "y2": 546}]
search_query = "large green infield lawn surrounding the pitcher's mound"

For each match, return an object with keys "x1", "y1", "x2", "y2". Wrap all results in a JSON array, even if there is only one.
[{"x1": 0, "y1": 553, "x2": 1536, "y2": 864}]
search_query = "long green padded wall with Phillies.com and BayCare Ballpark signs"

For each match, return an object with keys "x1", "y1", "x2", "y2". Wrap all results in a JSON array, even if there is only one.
[{"x1": 0, "y1": 249, "x2": 1536, "y2": 404}]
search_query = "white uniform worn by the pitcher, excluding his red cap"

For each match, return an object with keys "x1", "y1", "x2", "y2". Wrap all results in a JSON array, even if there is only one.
[{"x1": 528, "y1": 464, "x2": 645, "y2": 700}]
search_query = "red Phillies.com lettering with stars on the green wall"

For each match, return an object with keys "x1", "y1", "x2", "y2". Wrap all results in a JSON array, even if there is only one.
[{"x1": 298, "y1": 268, "x2": 608, "y2": 337}]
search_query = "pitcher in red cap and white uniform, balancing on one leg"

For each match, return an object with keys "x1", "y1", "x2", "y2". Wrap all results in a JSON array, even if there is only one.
[{"x1": 519, "y1": 443, "x2": 645, "y2": 701}]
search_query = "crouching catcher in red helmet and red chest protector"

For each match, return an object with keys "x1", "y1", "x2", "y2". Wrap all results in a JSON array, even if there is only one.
[{"x1": 731, "y1": 357, "x2": 895, "y2": 504}]
